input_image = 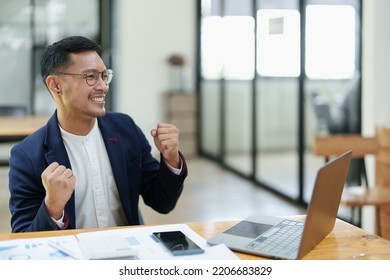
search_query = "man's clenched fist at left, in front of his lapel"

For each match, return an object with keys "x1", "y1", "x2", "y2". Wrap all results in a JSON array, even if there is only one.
[{"x1": 41, "y1": 162, "x2": 76, "y2": 220}]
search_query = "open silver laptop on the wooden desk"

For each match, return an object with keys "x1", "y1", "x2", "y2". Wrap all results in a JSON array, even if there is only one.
[{"x1": 207, "y1": 151, "x2": 352, "y2": 260}]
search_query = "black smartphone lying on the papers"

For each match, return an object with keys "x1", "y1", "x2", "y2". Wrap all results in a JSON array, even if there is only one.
[{"x1": 153, "y1": 231, "x2": 204, "y2": 256}]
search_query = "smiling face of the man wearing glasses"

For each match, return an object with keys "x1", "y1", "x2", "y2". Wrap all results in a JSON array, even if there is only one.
[{"x1": 57, "y1": 51, "x2": 109, "y2": 119}]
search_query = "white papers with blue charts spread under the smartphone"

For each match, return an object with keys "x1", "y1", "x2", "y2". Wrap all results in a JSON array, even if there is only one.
[{"x1": 0, "y1": 224, "x2": 238, "y2": 260}]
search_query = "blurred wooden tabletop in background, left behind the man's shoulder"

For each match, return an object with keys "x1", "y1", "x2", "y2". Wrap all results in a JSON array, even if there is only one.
[{"x1": 0, "y1": 116, "x2": 49, "y2": 143}]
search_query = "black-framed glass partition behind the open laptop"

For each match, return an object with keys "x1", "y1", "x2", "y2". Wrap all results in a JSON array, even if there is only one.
[{"x1": 198, "y1": 0, "x2": 361, "y2": 204}]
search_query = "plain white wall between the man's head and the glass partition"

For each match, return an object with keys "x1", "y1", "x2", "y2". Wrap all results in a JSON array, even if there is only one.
[{"x1": 114, "y1": 0, "x2": 196, "y2": 153}]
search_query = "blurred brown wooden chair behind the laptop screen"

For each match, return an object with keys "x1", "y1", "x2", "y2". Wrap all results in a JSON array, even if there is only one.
[{"x1": 312, "y1": 133, "x2": 390, "y2": 236}]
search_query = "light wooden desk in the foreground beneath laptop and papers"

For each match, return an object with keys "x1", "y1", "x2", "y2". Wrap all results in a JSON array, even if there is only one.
[{"x1": 0, "y1": 219, "x2": 390, "y2": 260}]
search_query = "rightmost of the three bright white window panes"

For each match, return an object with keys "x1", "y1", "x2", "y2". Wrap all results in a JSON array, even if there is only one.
[{"x1": 306, "y1": 5, "x2": 356, "y2": 79}]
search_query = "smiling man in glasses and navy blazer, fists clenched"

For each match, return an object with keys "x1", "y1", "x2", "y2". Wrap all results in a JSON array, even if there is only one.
[{"x1": 9, "y1": 36, "x2": 187, "y2": 232}]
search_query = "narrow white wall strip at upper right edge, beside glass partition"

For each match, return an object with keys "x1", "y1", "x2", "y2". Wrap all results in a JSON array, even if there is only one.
[{"x1": 362, "y1": 0, "x2": 390, "y2": 134}]
